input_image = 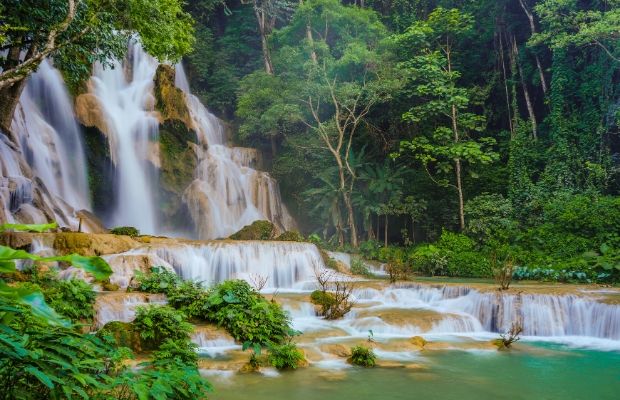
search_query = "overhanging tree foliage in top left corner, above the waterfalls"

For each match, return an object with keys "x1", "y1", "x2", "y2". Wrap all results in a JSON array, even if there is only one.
[{"x1": 0, "y1": 0, "x2": 194, "y2": 85}]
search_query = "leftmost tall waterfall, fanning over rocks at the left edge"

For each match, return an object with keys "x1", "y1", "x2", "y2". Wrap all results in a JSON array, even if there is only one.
[{"x1": 0, "y1": 60, "x2": 90, "y2": 230}]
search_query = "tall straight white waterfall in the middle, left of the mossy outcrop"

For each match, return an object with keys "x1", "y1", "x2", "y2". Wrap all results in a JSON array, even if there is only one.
[{"x1": 90, "y1": 45, "x2": 159, "y2": 233}]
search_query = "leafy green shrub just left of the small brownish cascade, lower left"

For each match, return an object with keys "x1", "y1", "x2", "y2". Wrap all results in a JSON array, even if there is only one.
[{"x1": 43, "y1": 279, "x2": 97, "y2": 322}]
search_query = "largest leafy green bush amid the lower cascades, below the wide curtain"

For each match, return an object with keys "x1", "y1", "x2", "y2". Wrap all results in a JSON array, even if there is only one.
[{"x1": 201, "y1": 280, "x2": 294, "y2": 346}]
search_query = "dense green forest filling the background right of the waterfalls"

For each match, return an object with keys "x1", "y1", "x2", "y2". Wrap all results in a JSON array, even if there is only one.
[{"x1": 178, "y1": 0, "x2": 620, "y2": 282}]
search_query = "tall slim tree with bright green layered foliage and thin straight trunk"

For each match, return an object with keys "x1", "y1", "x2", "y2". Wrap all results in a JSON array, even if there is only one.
[{"x1": 394, "y1": 8, "x2": 497, "y2": 229}]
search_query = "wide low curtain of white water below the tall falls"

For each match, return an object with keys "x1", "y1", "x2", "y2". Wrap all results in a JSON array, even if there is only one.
[{"x1": 128, "y1": 241, "x2": 324, "y2": 291}]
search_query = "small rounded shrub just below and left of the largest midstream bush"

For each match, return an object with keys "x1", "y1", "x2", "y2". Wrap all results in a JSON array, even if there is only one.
[{"x1": 133, "y1": 305, "x2": 193, "y2": 349}]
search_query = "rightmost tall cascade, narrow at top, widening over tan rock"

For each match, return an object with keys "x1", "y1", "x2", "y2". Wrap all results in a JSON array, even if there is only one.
[{"x1": 175, "y1": 62, "x2": 295, "y2": 239}]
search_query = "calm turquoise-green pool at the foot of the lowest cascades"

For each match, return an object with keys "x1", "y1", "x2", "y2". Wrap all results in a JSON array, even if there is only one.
[{"x1": 211, "y1": 345, "x2": 620, "y2": 400}]
